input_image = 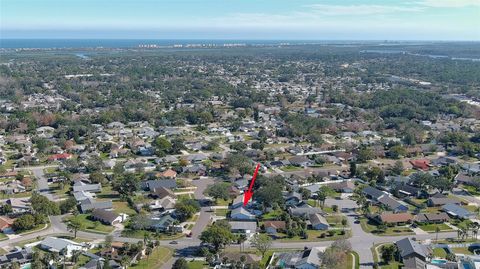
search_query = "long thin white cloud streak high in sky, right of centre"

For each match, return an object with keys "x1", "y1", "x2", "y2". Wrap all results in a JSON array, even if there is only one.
[{"x1": 307, "y1": 4, "x2": 425, "y2": 16}]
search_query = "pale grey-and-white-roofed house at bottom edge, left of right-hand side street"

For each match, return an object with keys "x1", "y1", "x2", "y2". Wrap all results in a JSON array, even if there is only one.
[{"x1": 275, "y1": 247, "x2": 325, "y2": 269}]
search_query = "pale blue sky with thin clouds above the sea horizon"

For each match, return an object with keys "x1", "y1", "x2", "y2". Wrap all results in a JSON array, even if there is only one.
[{"x1": 0, "y1": 0, "x2": 480, "y2": 41}]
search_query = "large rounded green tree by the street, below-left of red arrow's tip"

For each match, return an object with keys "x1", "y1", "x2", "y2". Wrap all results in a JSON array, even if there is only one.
[{"x1": 200, "y1": 221, "x2": 234, "y2": 253}]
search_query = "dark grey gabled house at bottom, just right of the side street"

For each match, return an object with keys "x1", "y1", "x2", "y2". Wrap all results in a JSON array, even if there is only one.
[{"x1": 395, "y1": 237, "x2": 432, "y2": 269}]
